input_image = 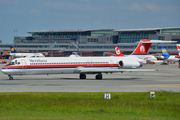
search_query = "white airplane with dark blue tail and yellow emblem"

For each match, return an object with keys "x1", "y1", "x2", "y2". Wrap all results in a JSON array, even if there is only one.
[{"x1": 9, "y1": 46, "x2": 45, "y2": 58}]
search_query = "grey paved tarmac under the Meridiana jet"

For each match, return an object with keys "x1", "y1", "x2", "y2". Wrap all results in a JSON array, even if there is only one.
[{"x1": 0, "y1": 61, "x2": 180, "y2": 92}]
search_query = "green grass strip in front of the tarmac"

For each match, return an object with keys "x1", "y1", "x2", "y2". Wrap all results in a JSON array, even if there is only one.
[{"x1": 0, "y1": 92, "x2": 180, "y2": 120}]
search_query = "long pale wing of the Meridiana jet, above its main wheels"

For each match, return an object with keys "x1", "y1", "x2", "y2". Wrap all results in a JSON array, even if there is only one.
[{"x1": 79, "y1": 68, "x2": 156, "y2": 74}]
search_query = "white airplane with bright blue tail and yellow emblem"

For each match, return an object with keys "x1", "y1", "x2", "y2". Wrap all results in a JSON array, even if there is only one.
[{"x1": 161, "y1": 46, "x2": 180, "y2": 63}]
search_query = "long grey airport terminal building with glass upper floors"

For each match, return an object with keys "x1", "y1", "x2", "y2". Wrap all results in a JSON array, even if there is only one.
[{"x1": 0, "y1": 27, "x2": 180, "y2": 56}]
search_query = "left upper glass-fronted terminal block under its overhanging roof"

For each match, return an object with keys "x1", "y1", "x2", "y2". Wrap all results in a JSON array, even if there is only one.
[{"x1": 14, "y1": 29, "x2": 117, "y2": 44}]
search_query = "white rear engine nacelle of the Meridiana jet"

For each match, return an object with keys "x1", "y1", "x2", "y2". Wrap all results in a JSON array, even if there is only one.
[{"x1": 119, "y1": 60, "x2": 143, "y2": 69}]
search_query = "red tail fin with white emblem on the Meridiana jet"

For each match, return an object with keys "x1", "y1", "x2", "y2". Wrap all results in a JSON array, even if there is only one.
[{"x1": 132, "y1": 39, "x2": 152, "y2": 55}]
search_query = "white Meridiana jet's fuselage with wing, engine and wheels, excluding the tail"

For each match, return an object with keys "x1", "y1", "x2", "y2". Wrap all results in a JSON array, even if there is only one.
[{"x1": 1, "y1": 56, "x2": 155, "y2": 80}]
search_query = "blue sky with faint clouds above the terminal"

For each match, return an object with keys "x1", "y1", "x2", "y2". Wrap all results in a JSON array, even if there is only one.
[{"x1": 0, "y1": 0, "x2": 180, "y2": 43}]
